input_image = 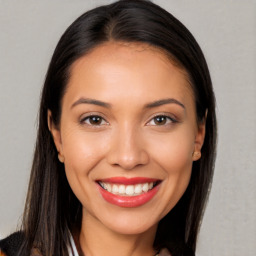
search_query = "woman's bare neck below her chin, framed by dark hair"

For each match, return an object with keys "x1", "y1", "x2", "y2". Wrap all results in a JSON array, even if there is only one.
[{"x1": 78, "y1": 209, "x2": 157, "y2": 256}]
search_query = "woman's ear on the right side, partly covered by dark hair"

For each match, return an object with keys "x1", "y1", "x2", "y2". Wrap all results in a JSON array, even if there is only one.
[{"x1": 192, "y1": 111, "x2": 207, "y2": 161}]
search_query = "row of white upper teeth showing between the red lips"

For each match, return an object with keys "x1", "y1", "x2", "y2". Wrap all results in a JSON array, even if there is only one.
[{"x1": 99, "y1": 182, "x2": 154, "y2": 196}]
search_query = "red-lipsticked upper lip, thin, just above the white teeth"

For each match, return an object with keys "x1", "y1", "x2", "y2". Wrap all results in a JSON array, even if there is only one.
[{"x1": 97, "y1": 177, "x2": 160, "y2": 185}]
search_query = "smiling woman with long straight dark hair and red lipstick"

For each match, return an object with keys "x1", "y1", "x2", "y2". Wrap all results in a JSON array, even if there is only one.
[{"x1": 0, "y1": 0, "x2": 216, "y2": 256}]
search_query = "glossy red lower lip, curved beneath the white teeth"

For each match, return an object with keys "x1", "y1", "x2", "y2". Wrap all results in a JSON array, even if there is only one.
[{"x1": 98, "y1": 185, "x2": 159, "y2": 208}]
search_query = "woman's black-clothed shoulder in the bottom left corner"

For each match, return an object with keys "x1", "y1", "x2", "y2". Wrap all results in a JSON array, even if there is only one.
[{"x1": 0, "y1": 231, "x2": 24, "y2": 256}]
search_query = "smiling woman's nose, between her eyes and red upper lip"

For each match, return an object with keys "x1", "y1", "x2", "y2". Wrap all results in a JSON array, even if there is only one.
[{"x1": 107, "y1": 126, "x2": 149, "y2": 170}]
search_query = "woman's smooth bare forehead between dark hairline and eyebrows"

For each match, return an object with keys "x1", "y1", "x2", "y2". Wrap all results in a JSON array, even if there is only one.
[{"x1": 64, "y1": 42, "x2": 193, "y2": 105}]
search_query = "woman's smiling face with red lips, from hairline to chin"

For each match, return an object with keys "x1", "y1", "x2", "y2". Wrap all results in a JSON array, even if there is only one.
[{"x1": 49, "y1": 42, "x2": 204, "y2": 234}]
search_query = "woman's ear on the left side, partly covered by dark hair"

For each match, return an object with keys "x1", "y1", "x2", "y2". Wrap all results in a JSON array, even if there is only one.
[{"x1": 47, "y1": 109, "x2": 64, "y2": 163}]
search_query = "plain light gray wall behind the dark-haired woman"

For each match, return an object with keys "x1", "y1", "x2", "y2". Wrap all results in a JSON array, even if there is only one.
[{"x1": 0, "y1": 0, "x2": 256, "y2": 256}]
